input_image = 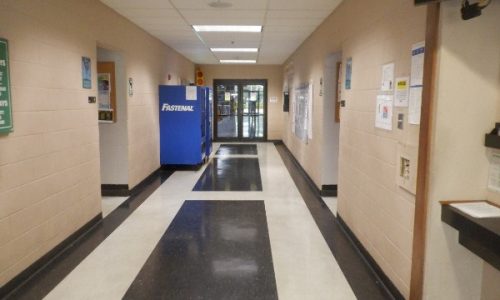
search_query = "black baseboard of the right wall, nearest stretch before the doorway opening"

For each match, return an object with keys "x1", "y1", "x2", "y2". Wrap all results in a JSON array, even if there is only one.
[{"x1": 337, "y1": 213, "x2": 405, "y2": 300}]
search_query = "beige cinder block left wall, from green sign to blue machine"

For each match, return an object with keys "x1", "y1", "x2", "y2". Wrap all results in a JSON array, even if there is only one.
[{"x1": 0, "y1": 0, "x2": 194, "y2": 286}]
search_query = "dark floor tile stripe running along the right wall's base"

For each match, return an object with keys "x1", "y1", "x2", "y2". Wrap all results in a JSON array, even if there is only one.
[{"x1": 276, "y1": 143, "x2": 403, "y2": 300}]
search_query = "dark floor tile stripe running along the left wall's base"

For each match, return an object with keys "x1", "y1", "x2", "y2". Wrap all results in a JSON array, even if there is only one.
[{"x1": 2, "y1": 170, "x2": 173, "y2": 299}]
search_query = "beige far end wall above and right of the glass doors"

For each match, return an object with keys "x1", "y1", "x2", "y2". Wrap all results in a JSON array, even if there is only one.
[{"x1": 199, "y1": 65, "x2": 284, "y2": 140}]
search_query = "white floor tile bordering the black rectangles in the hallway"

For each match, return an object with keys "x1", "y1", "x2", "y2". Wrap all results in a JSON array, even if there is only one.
[{"x1": 46, "y1": 143, "x2": 355, "y2": 300}]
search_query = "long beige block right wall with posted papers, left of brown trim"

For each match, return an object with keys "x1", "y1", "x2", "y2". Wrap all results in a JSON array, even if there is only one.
[{"x1": 284, "y1": 0, "x2": 426, "y2": 297}]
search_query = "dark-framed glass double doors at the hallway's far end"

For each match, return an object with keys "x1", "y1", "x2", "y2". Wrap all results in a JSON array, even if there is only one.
[{"x1": 214, "y1": 79, "x2": 267, "y2": 141}]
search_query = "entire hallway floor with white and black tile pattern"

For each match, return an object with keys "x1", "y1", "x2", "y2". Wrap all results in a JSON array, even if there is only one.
[{"x1": 5, "y1": 143, "x2": 387, "y2": 300}]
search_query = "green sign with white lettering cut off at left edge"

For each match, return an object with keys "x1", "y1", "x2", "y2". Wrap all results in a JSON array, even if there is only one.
[{"x1": 0, "y1": 38, "x2": 12, "y2": 134}]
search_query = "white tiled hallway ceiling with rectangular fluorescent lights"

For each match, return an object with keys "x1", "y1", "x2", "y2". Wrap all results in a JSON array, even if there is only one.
[{"x1": 101, "y1": 0, "x2": 342, "y2": 64}]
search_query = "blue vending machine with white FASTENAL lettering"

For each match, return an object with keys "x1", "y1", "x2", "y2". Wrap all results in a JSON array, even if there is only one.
[{"x1": 159, "y1": 85, "x2": 208, "y2": 167}]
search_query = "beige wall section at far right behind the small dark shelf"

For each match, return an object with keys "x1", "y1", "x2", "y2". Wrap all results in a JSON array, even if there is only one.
[{"x1": 424, "y1": 1, "x2": 500, "y2": 300}]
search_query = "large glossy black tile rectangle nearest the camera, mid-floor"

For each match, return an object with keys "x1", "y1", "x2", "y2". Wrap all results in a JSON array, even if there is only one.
[{"x1": 124, "y1": 201, "x2": 278, "y2": 300}]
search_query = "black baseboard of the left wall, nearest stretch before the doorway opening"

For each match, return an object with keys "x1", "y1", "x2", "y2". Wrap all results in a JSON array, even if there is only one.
[{"x1": 0, "y1": 213, "x2": 102, "y2": 299}]
